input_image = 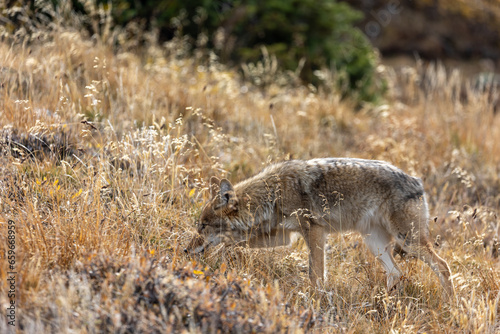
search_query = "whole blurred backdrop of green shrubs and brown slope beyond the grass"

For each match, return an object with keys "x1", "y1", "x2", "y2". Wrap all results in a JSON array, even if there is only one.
[{"x1": 0, "y1": 0, "x2": 500, "y2": 103}]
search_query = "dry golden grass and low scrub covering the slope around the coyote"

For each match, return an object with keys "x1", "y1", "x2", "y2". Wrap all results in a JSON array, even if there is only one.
[{"x1": 0, "y1": 6, "x2": 500, "y2": 333}]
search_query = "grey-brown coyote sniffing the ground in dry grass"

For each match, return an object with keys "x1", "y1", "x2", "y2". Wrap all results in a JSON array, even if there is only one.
[{"x1": 188, "y1": 158, "x2": 454, "y2": 297}]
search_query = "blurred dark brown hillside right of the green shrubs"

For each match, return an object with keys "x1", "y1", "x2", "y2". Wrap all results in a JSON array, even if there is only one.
[{"x1": 347, "y1": 0, "x2": 500, "y2": 61}]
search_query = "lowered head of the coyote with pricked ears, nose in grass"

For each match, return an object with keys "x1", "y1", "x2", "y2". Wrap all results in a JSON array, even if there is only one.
[{"x1": 186, "y1": 177, "x2": 247, "y2": 253}]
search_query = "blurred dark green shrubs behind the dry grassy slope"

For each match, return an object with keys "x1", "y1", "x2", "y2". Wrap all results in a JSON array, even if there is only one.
[{"x1": 0, "y1": 0, "x2": 386, "y2": 102}]
